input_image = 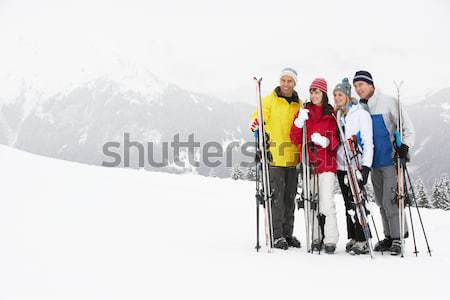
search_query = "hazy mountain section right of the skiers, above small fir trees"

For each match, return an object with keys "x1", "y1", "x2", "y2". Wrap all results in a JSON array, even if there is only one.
[{"x1": 406, "y1": 88, "x2": 450, "y2": 189}]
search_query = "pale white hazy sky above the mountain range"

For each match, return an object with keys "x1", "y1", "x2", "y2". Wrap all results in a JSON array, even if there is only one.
[{"x1": 0, "y1": 0, "x2": 450, "y2": 101}]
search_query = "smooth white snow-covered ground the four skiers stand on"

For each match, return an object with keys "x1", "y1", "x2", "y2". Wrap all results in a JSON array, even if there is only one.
[{"x1": 0, "y1": 146, "x2": 450, "y2": 299}]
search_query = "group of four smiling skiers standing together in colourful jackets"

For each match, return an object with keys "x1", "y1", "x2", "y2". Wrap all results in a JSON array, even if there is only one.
[{"x1": 250, "y1": 68, "x2": 415, "y2": 255}]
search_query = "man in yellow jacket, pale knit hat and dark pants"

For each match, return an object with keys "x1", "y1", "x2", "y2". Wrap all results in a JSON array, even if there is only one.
[{"x1": 250, "y1": 68, "x2": 303, "y2": 250}]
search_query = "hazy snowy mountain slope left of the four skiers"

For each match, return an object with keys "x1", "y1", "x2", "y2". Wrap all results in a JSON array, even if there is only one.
[{"x1": 0, "y1": 65, "x2": 253, "y2": 177}]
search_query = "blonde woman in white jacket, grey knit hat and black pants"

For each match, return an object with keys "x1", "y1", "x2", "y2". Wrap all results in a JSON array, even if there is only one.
[{"x1": 333, "y1": 78, "x2": 373, "y2": 254}]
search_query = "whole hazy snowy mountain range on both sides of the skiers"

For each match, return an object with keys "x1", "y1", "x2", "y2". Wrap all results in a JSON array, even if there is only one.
[{"x1": 0, "y1": 64, "x2": 450, "y2": 184}]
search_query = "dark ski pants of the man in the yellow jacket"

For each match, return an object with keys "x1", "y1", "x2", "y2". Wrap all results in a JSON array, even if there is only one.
[{"x1": 269, "y1": 166, "x2": 298, "y2": 240}]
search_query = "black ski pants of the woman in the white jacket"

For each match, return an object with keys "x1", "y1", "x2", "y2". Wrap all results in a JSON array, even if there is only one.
[{"x1": 337, "y1": 170, "x2": 370, "y2": 242}]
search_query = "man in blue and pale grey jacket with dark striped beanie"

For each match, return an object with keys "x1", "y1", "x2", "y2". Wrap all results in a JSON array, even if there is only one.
[{"x1": 353, "y1": 71, "x2": 415, "y2": 255}]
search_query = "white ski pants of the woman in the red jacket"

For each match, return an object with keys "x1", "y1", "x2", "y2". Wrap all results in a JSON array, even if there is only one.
[{"x1": 310, "y1": 172, "x2": 339, "y2": 244}]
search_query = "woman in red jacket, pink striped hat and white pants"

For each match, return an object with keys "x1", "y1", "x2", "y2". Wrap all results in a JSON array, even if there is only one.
[{"x1": 291, "y1": 78, "x2": 339, "y2": 254}]
